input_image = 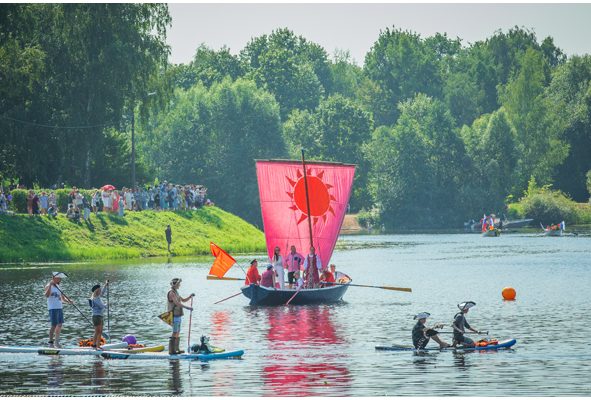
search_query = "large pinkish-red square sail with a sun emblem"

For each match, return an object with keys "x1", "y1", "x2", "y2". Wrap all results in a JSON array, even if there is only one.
[{"x1": 256, "y1": 161, "x2": 355, "y2": 265}]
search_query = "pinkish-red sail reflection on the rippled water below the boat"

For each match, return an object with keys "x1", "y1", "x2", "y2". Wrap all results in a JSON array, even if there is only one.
[{"x1": 263, "y1": 306, "x2": 351, "y2": 396}]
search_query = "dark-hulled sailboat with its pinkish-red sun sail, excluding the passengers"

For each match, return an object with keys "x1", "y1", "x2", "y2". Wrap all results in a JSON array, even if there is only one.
[{"x1": 241, "y1": 152, "x2": 355, "y2": 305}]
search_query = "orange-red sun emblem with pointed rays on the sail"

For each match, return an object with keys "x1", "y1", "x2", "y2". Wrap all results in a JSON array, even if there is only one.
[{"x1": 285, "y1": 169, "x2": 336, "y2": 224}]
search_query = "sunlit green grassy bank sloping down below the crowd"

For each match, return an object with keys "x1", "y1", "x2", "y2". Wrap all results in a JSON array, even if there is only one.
[{"x1": 0, "y1": 207, "x2": 265, "y2": 263}]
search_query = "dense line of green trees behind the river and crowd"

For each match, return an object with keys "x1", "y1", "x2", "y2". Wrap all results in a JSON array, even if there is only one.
[{"x1": 0, "y1": 4, "x2": 591, "y2": 228}]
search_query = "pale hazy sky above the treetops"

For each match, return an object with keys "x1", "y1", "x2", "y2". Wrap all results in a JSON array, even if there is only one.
[{"x1": 168, "y1": 3, "x2": 591, "y2": 65}]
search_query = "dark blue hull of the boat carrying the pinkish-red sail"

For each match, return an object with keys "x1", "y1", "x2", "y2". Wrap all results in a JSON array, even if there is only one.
[{"x1": 240, "y1": 285, "x2": 349, "y2": 306}]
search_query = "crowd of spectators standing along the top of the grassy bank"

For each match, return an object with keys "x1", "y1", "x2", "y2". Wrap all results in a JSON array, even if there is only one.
[{"x1": 0, "y1": 181, "x2": 214, "y2": 221}]
